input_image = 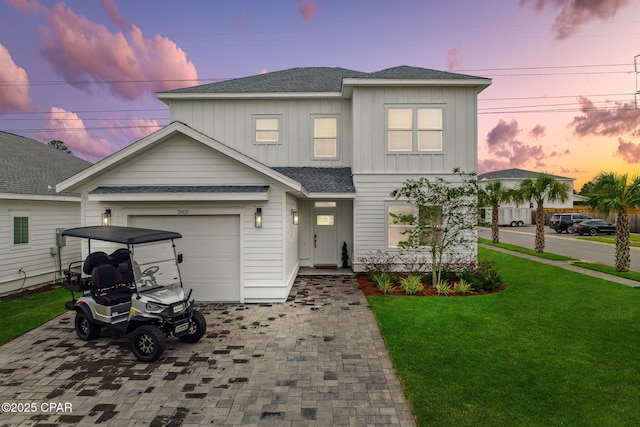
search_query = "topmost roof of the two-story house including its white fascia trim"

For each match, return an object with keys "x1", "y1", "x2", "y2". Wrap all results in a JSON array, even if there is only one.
[{"x1": 157, "y1": 65, "x2": 491, "y2": 100}]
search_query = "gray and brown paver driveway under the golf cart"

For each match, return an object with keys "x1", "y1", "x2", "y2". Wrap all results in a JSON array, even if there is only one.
[{"x1": 0, "y1": 276, "x2": 415, "y2": 426}]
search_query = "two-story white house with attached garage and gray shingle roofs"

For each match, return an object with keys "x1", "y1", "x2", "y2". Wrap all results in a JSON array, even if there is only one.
[{"x1": 58, "y1": 66, "x2": 491, "y2": 302}]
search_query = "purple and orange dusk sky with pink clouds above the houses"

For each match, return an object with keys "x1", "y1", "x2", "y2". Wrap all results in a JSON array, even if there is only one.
[{"x1": 0, "y1": 0, "x2": 640, "y2": 189}]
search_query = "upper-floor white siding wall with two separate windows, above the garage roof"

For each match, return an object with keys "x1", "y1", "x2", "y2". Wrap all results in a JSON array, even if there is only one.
[{"x1": 171, "y1": 99, "x2": 353, "y2": 166}]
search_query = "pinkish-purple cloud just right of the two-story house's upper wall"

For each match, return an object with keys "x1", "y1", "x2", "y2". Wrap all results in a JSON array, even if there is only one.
[{"x1": 478, "y1": 119, "x2": 547, "y2": 173}]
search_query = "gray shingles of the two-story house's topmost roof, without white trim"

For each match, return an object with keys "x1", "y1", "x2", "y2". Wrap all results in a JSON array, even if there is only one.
[{"x1": 161, "y1": 65, "x2": 488, "y2": 94}]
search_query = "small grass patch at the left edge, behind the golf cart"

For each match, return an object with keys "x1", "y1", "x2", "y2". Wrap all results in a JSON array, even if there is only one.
[{"x1": 0, "y1": 288, "x2": 71, "y2": 345}]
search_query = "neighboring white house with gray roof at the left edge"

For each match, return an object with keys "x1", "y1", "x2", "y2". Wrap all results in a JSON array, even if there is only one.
[{"x1": 0, "y1": 132, "x2": 91, "y2": 295}]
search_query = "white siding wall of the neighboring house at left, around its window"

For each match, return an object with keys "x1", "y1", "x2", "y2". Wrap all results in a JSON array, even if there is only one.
[{"x1": 0, "y1": 200, "x2": 81, "y2": 295}]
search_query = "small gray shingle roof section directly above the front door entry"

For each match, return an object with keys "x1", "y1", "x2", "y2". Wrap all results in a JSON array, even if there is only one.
[{"x1": 272, "y1": 167, "x2": 356, "y2": 193}]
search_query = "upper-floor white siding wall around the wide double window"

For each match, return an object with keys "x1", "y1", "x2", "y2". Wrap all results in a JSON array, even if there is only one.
[{"x1": 353, "y1": 87, "x2": 478, "y2": 174}]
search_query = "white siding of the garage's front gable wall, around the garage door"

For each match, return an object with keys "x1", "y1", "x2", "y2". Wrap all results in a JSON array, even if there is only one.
[{"x1": 75, "y1": 136, "x2": 297, "y2": 301}]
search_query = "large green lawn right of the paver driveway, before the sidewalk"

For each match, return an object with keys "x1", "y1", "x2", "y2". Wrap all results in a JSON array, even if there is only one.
[{"x1": 369, "y1": 248, "x2": 640, "y2": 426}]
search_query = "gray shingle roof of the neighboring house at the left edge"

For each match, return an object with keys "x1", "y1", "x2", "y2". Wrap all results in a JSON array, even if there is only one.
[{"x1": 0, "y1": 131, "x2": 91, "y2": 195}]
